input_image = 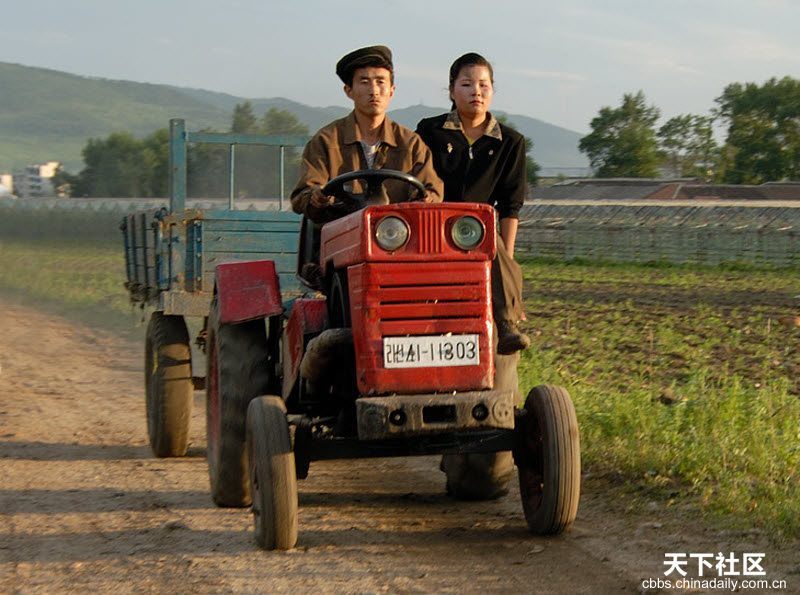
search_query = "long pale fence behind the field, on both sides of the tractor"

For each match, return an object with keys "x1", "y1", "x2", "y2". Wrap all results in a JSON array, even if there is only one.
[{"x1": 0, "y1": 199, "x2": 800, "y2": 267}]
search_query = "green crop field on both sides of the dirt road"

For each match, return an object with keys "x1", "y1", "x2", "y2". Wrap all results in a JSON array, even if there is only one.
[{"x1": 0, "y1": 239, "x2": 800, "y2": 538}]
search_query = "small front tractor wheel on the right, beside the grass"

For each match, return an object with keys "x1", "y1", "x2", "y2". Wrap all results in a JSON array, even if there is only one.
[{"x1": 514, "y1": 385, "x2": 581, "y2": 535}]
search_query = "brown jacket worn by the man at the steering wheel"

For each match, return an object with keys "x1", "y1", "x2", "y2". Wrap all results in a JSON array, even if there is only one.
[{"x1": 292, "y1": 112, "x2": 444, "y2": 222}]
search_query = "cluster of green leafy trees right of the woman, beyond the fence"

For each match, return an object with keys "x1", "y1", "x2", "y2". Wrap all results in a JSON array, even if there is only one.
[{"x1": 579, "y1": 76, "x2": 800, "y2": 184}]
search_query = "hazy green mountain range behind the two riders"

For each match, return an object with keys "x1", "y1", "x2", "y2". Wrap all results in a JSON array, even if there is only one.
[{"x1": 0, "y1": 62, "x2": 587, "y2": 172}]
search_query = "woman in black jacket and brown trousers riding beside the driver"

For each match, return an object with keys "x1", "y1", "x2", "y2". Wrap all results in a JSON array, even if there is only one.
[{"x1": 417, "y1": 52, "x2": 530, "y2": 355}]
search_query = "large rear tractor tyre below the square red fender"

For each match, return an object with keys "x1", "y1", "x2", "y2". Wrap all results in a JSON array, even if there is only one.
[{"x1": 206, "y1": 299, "x2": 270, "y2": 507}]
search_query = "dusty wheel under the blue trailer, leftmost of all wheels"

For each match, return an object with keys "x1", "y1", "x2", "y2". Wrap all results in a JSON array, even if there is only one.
[{"x1": 144, "y1": 312, "x2": 194, "y2": 457}]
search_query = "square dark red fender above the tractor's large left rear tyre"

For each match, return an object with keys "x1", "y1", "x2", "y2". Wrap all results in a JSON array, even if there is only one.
[{"x1": 214, "y1": 260, "x2": 283, "y2": 324}]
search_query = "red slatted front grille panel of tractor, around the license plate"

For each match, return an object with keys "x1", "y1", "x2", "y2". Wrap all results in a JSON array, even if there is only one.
[{"x1": 348, "y1": 261, "x2": 494, "y2": 394}]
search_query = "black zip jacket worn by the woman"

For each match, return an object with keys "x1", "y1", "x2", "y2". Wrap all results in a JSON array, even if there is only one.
[{"x1": 417, "y1": 111, "x2": 528, "y2": 219}]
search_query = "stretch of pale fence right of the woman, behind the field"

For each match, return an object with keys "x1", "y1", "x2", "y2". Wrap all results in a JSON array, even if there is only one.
[{"x1": 517, "y1": 202, "x2": 800, "y2": 267}]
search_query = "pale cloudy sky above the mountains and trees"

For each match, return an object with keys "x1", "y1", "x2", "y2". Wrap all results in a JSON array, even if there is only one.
[{"x1": 0, "y1": 0, "x2": 800, "y2": 133}]
